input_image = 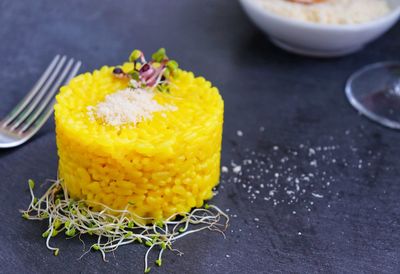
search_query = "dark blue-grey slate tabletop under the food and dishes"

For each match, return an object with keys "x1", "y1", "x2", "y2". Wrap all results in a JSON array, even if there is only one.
[{"x1": 0, "y1": 0, "x2": 400, "y2": 273}]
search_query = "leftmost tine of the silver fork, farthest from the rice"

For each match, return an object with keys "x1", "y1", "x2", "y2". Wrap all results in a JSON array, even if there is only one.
[{"x1": 3, "y1": 54, "x2": 60, "y2": 126}]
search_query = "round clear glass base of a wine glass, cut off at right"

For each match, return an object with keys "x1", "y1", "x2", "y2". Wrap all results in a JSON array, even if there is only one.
[{"x1": 346, "y1": 62, "x2": 400, "y2": 129}]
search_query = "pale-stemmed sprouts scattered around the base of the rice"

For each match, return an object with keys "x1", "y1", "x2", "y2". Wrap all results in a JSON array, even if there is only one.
[{"x1": 21, "y1": 180, "x2": 229, "y2": 273}]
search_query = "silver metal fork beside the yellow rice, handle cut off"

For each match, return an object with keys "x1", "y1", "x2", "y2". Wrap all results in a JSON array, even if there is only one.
[{"x1": 0, "y1": 55, "x2": 82, "y2": 148}]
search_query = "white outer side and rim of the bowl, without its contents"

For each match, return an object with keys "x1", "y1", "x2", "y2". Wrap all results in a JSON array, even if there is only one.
[{"x1": 239, "y1": 0, "x2": 400, "y2": 57}]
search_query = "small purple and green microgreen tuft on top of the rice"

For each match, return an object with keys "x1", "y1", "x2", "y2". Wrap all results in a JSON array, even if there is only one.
[{"x1": 113, "y1": 48, "x2": 179, "y2": 91}]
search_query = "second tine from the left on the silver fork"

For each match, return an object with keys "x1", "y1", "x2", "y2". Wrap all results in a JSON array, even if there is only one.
[{"x1": 9, "y1": 56, "x2": 67, "y2": 130}]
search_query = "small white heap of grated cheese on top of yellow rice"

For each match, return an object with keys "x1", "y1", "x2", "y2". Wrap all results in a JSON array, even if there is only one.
[{"x1": 87, "y1": 88, "x2": 177, "y2": 126}]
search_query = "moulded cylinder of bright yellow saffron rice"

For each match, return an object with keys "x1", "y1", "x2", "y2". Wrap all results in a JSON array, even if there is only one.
[{"x1": 55, "y1": 64, "x2": 224, "y2": 221}]
